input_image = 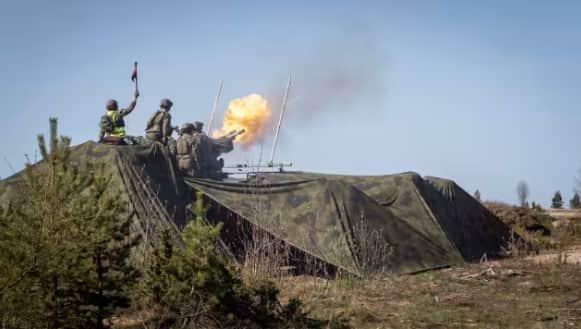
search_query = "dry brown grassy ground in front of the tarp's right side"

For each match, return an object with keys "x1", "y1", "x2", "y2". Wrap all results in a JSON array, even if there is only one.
[{"x1": 280, "y1": 217, "x2": 581, "y2": 329}]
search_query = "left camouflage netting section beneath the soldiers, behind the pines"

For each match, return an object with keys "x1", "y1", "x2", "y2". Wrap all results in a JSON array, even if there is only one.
[{"x1": 0, "y1": 142, "x2": 191, "y2": 239}]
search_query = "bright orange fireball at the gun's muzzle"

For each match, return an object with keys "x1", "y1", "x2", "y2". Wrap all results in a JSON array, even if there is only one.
[{"x1": 212, "y1": 94, "x2": 272, "y2": 146}]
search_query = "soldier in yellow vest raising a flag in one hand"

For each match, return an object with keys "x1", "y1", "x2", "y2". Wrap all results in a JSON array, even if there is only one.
[{"x1": 99, "y1": 90, "x2": 139, "y2": 145}]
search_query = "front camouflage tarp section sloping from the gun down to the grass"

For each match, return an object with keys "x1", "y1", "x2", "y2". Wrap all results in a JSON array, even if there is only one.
[{"x1": 186, "y1": 178, "x2": 463, "y2": 274}]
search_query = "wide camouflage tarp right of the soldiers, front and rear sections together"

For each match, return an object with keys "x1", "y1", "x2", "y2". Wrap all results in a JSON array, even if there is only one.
[{"x1": 186, "y1": 173, "x2": 509, "y2": 273}]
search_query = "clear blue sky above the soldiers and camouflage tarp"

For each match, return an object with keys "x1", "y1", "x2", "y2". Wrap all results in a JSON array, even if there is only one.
[{"x1": 0, "y1": 0, "x2": 581, "y2": 206}]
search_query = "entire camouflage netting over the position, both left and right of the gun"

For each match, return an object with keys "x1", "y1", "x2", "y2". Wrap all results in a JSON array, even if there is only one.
[{"x1": 0, "y1": 142, "x2": 509, "y2": 274}]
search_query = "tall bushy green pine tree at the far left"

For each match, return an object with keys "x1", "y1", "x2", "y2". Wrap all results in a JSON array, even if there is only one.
[{"x1": 0, "y1": 118, "x2": 138, "y2": 328}]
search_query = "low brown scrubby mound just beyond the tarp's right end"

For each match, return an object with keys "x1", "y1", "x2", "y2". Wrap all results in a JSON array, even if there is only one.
[{"x1": 484, "y1": 202, "x2": 556, "y2": 236}]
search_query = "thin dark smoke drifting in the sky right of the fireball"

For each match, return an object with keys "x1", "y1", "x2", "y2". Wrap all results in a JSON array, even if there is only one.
[{"x1": 273, "y1": 31, "x2": 387, "y2": 124}]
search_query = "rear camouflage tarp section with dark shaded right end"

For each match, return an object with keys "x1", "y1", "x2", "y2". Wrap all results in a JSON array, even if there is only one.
[{"x1": 245, "y1": 172, "x2": 511, "y2": 260}]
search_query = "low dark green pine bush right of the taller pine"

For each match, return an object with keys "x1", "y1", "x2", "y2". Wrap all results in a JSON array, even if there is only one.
[{"x1": 135, "y1": 193, "x2": 345, "y2": 328}]
